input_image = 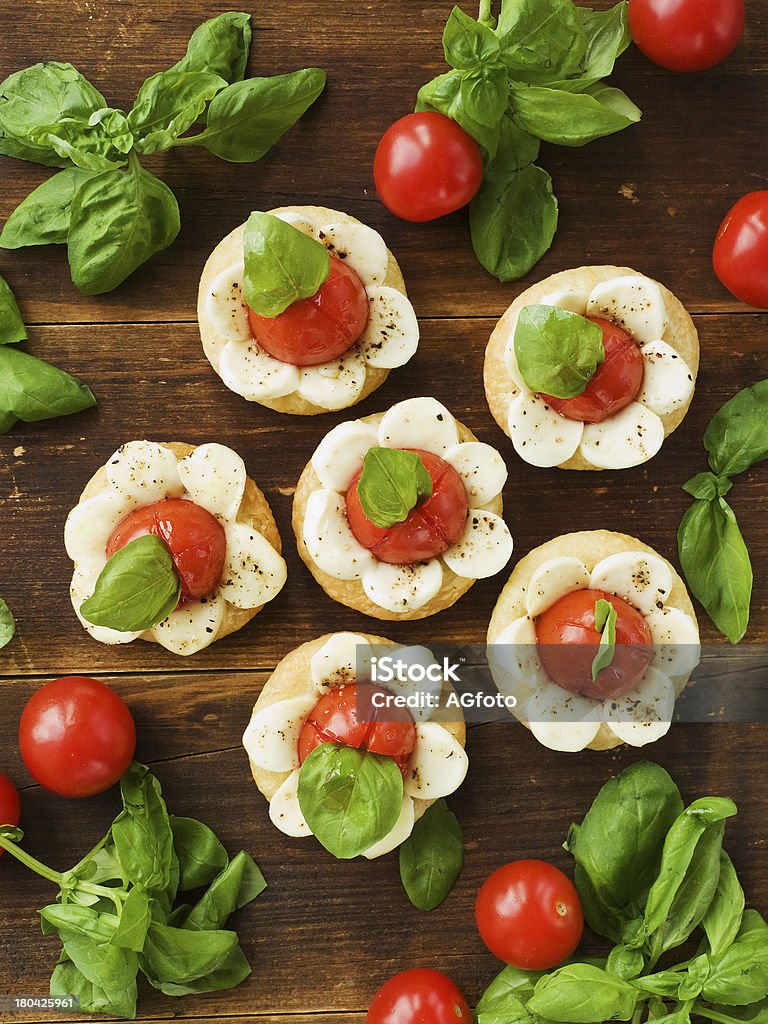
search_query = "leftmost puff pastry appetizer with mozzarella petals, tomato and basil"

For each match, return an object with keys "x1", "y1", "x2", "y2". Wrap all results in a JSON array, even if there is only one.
[{"x1": 65, "y1": 440, "x2": 286, "y2": 654}]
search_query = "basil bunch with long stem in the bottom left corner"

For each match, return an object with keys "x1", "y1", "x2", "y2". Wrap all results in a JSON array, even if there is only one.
[{"x1": 0, "y1": 762, "x2": 266, "y2": 1018}]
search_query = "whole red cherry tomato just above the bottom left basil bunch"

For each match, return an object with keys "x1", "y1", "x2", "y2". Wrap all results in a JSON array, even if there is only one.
[{"x1": 18, "y1": 676, "x2": 136, "y2": 797}]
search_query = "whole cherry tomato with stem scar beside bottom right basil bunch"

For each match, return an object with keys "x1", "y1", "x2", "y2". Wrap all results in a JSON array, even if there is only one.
[{"x1": 475, "y1": 860, "x2": 584, "y2": 971}]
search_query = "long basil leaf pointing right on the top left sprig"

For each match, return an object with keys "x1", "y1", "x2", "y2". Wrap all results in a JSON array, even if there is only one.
[{"x1": 191, "y1": 68, "x2": 326, "y2": 163}]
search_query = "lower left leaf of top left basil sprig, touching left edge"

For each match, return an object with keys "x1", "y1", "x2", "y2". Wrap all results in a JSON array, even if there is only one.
[{"x1": 0, "y1": 167, "x2": 93, "y2": 249}]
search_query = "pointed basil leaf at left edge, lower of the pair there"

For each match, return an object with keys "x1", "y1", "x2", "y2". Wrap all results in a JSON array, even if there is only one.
[{"x1": 0, "y1": 345, "x2": 96, "y2": 434}]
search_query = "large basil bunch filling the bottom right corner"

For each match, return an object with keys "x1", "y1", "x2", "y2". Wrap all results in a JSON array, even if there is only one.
[{"x1": 475, "y1": 762, "x2": 768, "y2": 1024}]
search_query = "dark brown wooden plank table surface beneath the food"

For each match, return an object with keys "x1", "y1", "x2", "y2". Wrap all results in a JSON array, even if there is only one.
[{"x1": 0, "y1": 0, "x2": 768, "y2": 1024}]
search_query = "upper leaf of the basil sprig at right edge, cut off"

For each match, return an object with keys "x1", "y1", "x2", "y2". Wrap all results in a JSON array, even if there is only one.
[{"x1": 703, "y1": 380, "x2": 768, "y2": 476}]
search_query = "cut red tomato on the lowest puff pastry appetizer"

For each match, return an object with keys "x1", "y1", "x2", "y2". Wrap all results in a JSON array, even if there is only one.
[{"x1": 299, "y1": 683, "x2": 416, "y2": 774}]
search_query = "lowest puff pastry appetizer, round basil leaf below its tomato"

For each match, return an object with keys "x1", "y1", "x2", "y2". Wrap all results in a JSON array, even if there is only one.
[{"x1": 243, "y1": 633, "x2": 468, "y2": 858}]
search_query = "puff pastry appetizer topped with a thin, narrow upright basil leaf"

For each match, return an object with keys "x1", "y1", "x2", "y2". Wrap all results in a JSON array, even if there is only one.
[{"x1": 487, "y1": 530, "x2": 700, "y2": 751}]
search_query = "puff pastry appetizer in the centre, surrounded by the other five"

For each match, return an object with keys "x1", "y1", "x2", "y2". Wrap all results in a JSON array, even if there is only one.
[{"x1": 293, "y1": 398, "x2": 512, "y2": 620}]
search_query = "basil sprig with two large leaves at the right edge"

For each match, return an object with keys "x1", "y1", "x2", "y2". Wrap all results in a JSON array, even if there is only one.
[{"x1": 678, "y1": 380, "x2": 768, "y2": 643}]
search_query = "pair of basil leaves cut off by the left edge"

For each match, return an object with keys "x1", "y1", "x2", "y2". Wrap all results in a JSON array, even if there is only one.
[{"x1": 0, "y1": 276, "x2": 96, "y2": 434}]
